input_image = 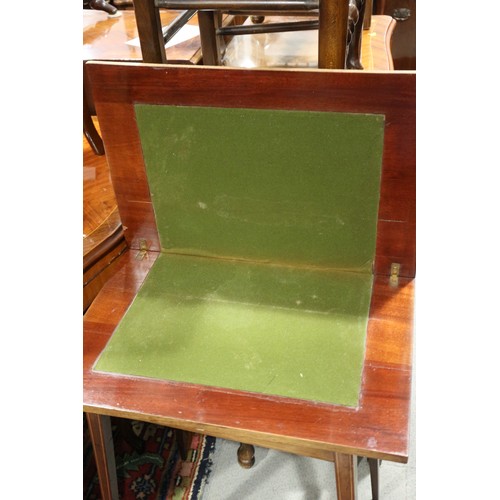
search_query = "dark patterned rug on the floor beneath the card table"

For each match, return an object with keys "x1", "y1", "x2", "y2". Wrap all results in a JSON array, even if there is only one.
[{"x1": 83, "y1": 417, "x2": 215, "y2": 500}]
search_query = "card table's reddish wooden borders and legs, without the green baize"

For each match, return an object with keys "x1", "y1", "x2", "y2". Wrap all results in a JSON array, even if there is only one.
[{"x1": 83, "y1": 63, "x2": 416, "y2": 500}]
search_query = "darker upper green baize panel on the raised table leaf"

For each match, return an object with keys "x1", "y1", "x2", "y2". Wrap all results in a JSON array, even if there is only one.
[{"x1": 135, "y1": 105, "x2": 384, "y2": 272}]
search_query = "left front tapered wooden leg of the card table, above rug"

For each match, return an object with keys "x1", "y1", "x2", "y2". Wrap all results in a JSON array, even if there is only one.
[{"x1": 87, "y1": 413, "x2": 118, "y2": 500}]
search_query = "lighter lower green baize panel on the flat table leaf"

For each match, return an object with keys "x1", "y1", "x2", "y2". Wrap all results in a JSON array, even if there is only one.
[{"x1": 95, "y1": 254, "x2": 372, "y2": 406}]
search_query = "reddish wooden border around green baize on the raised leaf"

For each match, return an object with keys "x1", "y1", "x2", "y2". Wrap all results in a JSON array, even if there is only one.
[{"x1": 87, "y1": 63, "x2": 416, "y2": 277}]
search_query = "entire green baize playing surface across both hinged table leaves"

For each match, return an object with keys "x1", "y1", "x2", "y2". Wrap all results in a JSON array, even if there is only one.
[{"x1": 95, "y1": 105, "x2": 384, "y2": 406}]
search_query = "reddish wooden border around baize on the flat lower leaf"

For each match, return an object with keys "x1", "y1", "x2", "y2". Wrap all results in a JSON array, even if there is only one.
[{"x1": 83, "y1": 250, "x2": 414, "y2": 462}]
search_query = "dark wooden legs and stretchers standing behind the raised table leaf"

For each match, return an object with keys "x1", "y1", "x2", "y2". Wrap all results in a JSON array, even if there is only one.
[{"x1": 134, "y1": 0, "x2": 365, "y2": 69}]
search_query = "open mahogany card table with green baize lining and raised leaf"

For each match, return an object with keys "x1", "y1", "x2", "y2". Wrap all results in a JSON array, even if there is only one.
[{"x1": 83, "y1": 62, "x2": 415, "y2": 500}]
